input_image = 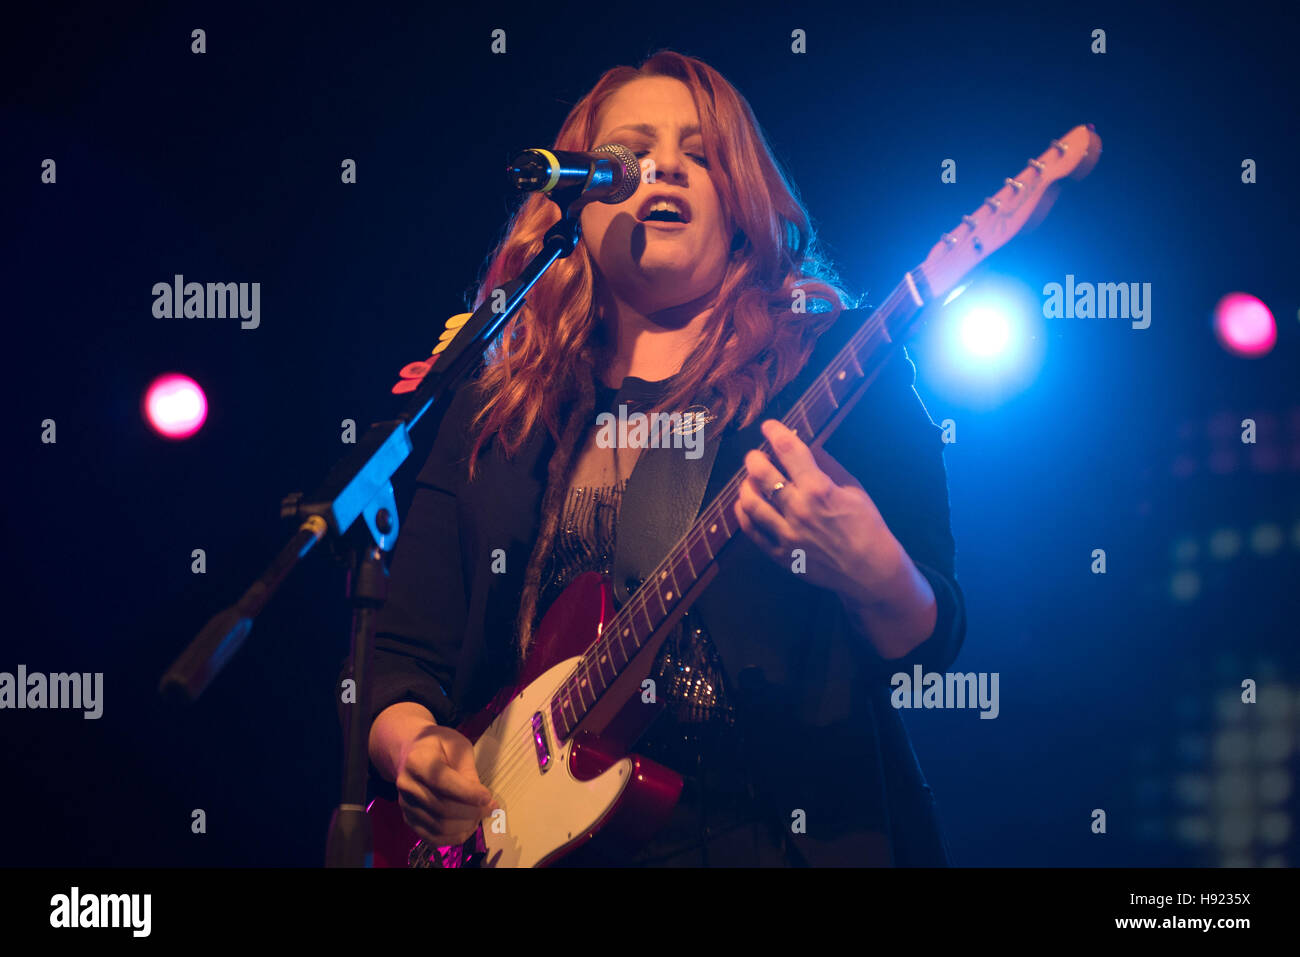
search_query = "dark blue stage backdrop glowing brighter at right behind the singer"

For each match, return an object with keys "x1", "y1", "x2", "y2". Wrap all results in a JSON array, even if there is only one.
[{"x1": 0, "y1": 3, "x2": 1300, "y2": 866}]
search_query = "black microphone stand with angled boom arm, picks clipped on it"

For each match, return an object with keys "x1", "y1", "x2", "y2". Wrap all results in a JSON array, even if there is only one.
[{"x1": 159, "y1": 183, "x2": 598, "y2": 867}]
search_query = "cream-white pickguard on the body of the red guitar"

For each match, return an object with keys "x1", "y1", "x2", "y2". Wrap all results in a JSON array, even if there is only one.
[{"x1": 475, "y1": 657, "x2": 632, "y2": 867}]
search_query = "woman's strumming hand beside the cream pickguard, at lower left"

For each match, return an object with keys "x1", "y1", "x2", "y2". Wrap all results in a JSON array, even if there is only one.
[{"x1": 394, "y1": 724, "x2": 498, "y2": 848}]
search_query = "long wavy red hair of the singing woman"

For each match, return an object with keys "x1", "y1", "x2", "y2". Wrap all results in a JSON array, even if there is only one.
[{"x1": 469, "y1": 51, "x2": 852, "y2": 475}]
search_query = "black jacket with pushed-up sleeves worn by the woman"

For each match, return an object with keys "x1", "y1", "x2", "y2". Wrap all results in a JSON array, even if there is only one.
[{"x1": 341, "y1": 311, "x2": 966, "y2": 866}]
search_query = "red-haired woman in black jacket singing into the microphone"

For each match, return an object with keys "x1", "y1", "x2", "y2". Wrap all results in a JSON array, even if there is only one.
[{"x1": 345, "y1": 46, "x2": 966, "y2": 866}]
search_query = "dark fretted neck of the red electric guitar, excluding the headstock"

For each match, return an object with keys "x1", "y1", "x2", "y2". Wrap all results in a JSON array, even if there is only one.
[{"x1": 550, "y1": 267, "x2": 931, "y2": 740}]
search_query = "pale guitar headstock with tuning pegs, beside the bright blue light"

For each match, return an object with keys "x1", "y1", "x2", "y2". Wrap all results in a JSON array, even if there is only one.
[{"x1": 920, "y1": 124, "x2": 1101, "y2": 298}]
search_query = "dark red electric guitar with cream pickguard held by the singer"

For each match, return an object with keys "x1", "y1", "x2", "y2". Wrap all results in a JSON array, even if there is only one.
[{"x1": 369, "y1": 125, "x2": 1101, "y2": 867}]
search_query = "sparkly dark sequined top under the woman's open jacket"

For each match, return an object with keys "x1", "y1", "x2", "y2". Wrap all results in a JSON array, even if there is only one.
[{"x1": 538, "y1": 480, "x2": 735, "y2": 726}]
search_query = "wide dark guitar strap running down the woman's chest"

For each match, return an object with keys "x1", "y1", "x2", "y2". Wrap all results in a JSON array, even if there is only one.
[{"x1": 611, "y1": 390, "x2": 722, "y2": 606}]
